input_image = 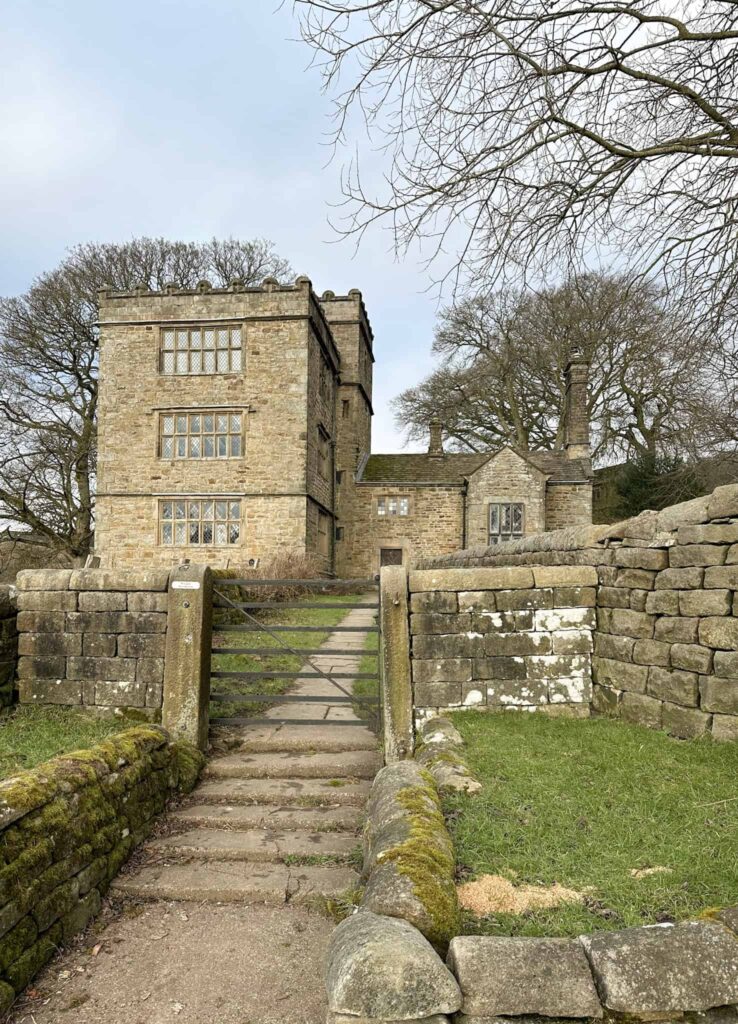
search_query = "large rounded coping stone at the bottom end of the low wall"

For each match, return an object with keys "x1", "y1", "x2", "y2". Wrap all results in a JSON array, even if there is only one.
[{"x1": 325, "y1": 910, "x2": 462, "y2": 1021}]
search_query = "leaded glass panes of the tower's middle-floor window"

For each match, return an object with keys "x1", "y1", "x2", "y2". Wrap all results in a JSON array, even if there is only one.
[{"x1": 159, "y1": 410, "x2": 244, "y2": 459}]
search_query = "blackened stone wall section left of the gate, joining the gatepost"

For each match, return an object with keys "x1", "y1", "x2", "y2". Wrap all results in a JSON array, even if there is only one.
[{"x1": 17, "y1": 569, "x2": 169, "y2": 719}]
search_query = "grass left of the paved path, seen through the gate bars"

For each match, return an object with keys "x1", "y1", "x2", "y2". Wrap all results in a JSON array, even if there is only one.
[{"x1": 210, "y1": 594, "x2": 359, "y2": 718}]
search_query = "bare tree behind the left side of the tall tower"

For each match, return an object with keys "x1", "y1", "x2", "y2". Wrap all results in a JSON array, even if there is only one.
[{"x1": 0, "y1": 239, "x2": 291, "y2": 558}]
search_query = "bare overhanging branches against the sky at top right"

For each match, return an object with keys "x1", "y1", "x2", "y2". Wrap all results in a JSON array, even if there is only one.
[{"x1": 294, "y1": 0, "x2": 738, "y2": 309}]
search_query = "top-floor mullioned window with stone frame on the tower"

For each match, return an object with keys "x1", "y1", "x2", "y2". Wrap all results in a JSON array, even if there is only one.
[{"x1": 159, "y1": 322, "x2": 244, "y2": 377}]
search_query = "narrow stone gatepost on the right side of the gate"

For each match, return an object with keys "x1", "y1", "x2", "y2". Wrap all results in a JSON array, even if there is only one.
[{"x1": 380, "y1": 565, "x2": 415, "y2": 764}]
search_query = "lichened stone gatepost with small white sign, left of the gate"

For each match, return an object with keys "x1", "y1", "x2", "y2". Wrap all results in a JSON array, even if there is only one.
[{"x1": 162, "y1": 565, "x2": 213, "y2": 751}]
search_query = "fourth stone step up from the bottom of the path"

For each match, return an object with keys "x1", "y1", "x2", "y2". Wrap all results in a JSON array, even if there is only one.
[{"x1": 194, "y1": 778, "x2": 372, "y2": 807}]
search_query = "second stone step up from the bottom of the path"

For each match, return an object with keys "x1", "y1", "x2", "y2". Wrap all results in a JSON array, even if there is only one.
[{"x1": 146, "y1": 828, "x2": 360, "y2": 861}]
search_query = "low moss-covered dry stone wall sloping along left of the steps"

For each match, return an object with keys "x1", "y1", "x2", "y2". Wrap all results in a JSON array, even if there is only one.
[{"x1": 0, "y1": 726, "x2": 204, "y2": 1013}]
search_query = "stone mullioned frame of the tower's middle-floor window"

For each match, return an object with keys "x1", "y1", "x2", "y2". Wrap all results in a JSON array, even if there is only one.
[{"x1": 157, "y1": 409, "x2": 246, "y2": 462}]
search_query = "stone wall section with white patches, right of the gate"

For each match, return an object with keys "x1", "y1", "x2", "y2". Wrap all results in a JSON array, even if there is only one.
[{"x1": 409, "y1": 566, "x2": 597, "y2": 720}]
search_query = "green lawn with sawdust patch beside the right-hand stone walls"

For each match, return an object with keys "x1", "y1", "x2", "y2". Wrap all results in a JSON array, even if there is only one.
[{"x1": 444, "y1": 713, "x2": 738, "y2": 936}]
